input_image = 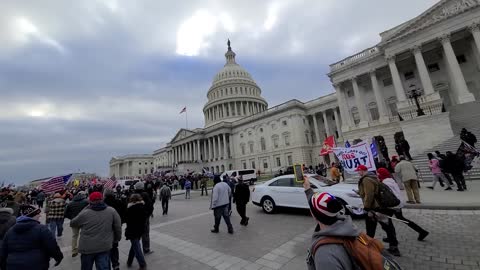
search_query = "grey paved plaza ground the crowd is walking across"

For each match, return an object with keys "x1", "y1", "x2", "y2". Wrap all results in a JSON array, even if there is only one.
[{"x1": 52, "y1": 191, "x2": 480, "y2": 270}]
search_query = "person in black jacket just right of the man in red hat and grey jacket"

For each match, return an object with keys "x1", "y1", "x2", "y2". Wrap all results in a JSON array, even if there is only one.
[{"x1": 125, "y1": 194, "x2": 147, "y2": 270}]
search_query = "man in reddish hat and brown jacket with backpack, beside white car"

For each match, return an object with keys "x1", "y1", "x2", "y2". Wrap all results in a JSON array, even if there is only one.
[{"x1": 355, "y1": 165, "x2": 400, "y2": 256}]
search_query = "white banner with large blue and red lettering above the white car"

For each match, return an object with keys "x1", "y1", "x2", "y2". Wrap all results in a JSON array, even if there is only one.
[{"x1": 333, "y1": 142, "x2": 377, "y2": 174}]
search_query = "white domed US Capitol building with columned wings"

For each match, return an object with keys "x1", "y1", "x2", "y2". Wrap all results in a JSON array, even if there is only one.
[{"x1": 110, "y1": 0, "x2": 480, "y2": 178}]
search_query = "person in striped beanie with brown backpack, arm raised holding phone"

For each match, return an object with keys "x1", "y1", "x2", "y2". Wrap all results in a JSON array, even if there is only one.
[{"x1": 303, "y1": 178, "x2": 401, "y2": 270}]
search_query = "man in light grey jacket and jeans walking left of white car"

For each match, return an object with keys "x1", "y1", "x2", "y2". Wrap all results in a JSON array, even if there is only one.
[{"x1": 210, "y1": 175, "x2": 233, "y2": 234}]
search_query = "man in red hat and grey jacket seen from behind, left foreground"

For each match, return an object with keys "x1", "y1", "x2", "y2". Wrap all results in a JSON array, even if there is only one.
[{"x1": 70, "y1": 191, "x2": 122, "y2": 270}]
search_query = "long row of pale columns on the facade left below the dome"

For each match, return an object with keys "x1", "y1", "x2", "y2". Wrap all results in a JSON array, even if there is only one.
[{"x1": 171, "y1": 133, "x2": 232, "y2": 166}]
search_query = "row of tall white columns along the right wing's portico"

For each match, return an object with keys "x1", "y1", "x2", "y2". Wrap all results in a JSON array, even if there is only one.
[{"x1": 333, "y1": 24, "x2": 480, "y2": 130}]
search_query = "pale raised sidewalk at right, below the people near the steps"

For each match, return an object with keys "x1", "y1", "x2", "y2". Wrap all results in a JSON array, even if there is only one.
[{"x1": 403, "y1": 180, "x2": 480, "y2": 210}]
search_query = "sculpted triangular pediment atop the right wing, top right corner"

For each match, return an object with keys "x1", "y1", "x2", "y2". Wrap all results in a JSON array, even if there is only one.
[{"x1": 380, "y1": 0, "x2": 480, "y2": 45}]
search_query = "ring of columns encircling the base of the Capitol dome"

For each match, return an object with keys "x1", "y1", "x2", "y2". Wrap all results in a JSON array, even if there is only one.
[{"x1": 205, "y1": 101, "x2": 267, "y2": 122}]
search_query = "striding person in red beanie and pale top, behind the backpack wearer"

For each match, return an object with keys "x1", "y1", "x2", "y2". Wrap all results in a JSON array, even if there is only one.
[{"x1": 377, "y1": 168, "x2": 429, "y2": 242}]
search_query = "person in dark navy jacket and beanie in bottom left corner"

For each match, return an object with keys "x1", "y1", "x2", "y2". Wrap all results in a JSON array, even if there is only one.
[{"x1": 0, "y1": 204, "x2": 63, "y2": 270}]
